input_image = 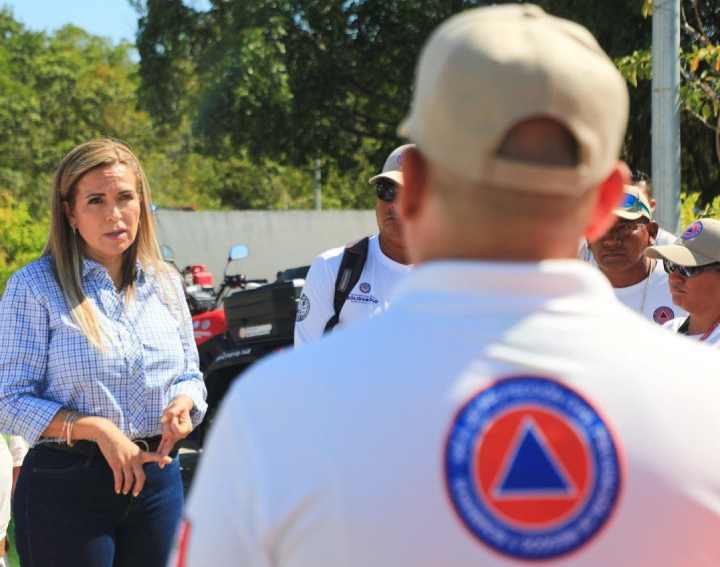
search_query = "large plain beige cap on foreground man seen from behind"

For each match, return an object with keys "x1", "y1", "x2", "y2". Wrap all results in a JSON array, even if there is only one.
[{"x1": 398, "y1": 4, "x2": 629, "y2": 194}]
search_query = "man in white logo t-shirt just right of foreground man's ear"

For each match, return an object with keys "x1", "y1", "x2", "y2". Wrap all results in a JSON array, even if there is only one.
[{"x1": 590, "y1": 185, "x2": 685, "y2": 324}]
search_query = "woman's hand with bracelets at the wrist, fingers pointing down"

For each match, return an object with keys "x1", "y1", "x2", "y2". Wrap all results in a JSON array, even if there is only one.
[{"x1": 96, "y1": 420, "x2": 172, "y2": 496}]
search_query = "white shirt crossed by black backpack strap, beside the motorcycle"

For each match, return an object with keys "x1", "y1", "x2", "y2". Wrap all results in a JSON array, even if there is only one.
[{"x1": 295, "y1": 234, "x2": 411, "y2": 346}]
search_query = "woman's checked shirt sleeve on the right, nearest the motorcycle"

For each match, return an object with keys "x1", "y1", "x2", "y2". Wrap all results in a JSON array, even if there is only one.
[{"x1": 168, "y1": 276, "x2": 207, "y2": 427}]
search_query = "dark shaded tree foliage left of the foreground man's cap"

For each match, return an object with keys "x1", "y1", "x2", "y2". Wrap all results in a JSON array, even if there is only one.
[{"x1": 135, "y1": 0, "x2": 470, "y2": 172}]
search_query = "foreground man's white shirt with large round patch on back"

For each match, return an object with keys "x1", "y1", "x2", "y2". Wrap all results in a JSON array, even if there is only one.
[{"x1": 181, "y1": 260, "x2": 720, "y2": 567}]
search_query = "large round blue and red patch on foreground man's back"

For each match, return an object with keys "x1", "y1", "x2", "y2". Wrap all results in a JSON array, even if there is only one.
[{"x1": 445, "y1": 376, "x2": 622, "y2": 560}]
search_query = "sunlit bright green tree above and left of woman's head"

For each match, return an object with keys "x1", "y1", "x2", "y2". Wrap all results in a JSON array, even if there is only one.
[{"x1": 0, "y1": 10, "x2": 156, "y2": 211}]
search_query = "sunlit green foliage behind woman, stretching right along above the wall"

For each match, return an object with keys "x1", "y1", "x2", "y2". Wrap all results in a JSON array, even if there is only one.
[{"x1": 0, "y1": 9, "x2": 340, "y2": 224}]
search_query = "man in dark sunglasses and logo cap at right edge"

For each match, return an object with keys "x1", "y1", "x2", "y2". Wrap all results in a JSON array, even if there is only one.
[{"x1": 645, "y1": 219, "x2": 720, "y2": 346}]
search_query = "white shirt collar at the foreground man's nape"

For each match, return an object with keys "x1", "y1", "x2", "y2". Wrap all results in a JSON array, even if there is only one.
[{"x1": 393, "y1": 260, "x2": 615, "y2": 309}]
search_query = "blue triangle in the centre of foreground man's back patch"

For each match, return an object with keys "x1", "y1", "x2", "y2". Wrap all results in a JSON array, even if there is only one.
[{"x1": 494, "y1": 417, "x2": 575, "y2": 498}]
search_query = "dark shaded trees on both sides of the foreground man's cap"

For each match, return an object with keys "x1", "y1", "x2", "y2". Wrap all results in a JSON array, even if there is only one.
[{"x1": 133, "y1": 0, "x2": 720, "y2": 209}]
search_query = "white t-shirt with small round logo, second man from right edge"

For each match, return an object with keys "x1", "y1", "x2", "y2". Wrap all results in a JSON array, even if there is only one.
[{"x1": 613, "y1": 260, "x2": 687, "y2": 325}]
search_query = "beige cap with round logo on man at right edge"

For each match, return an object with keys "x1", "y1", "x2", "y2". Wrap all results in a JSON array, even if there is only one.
[{"x1": 645, "y1": 219, "x2": 720, "y2": 266}]
